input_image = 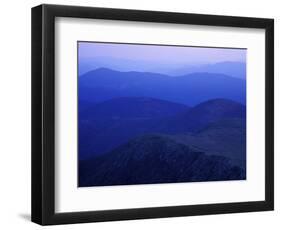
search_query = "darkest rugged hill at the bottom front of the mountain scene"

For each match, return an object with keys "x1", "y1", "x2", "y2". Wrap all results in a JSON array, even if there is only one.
[{"x1": 79, "y1": 135, "x2": 245, "y2": 187}]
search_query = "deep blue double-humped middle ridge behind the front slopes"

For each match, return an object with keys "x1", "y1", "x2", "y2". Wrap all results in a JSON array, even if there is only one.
[{"x1": 79, "y1": 98, "x2": 246, "y2": 159}]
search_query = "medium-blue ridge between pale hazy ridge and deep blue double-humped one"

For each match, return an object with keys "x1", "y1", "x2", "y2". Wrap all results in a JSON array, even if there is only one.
[{"x1": 79, "y1": 68, "x2": 246, "y2": 106}]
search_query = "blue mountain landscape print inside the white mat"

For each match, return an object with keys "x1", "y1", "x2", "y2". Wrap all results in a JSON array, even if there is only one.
[{"x1": 77, "y1": 41, "x2": 247, "y2": 187}]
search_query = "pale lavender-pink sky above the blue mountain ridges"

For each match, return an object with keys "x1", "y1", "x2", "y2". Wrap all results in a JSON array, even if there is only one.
[{"x1": 78, "y1": 42, "x2": 247, "y2": 73}]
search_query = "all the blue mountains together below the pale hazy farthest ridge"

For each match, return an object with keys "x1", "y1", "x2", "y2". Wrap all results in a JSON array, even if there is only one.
[{"x1": 78, "y1": 68, "x2": 246, "y2": 187}]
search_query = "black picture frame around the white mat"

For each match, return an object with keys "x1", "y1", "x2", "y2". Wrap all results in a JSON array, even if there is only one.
[{"x1": 31, "y1": 5, "x2": 274, "y2": 225}]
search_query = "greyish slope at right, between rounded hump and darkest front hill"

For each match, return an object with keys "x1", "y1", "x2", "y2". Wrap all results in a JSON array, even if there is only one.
[{"x1": 162, "y1": 118, "x2": 246, "y2": 169}]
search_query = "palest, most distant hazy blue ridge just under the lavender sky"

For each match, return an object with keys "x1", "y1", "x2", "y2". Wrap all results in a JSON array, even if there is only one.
[{"x1": 79, "y1": 57, "x2": 243, "y2": 79}]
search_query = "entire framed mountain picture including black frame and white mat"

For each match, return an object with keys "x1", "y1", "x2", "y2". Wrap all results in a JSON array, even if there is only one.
[{"x1": 32, "y1": 5, "x2": 274, "y2": 225}]
